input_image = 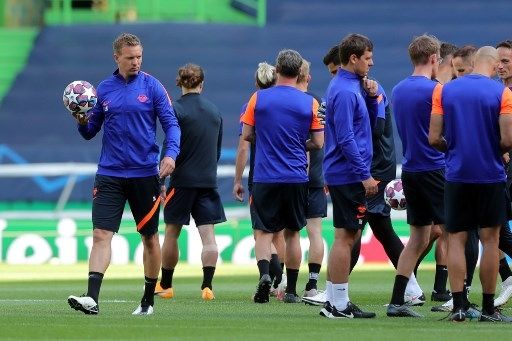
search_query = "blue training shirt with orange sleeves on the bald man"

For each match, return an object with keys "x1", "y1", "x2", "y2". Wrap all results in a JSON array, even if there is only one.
[{"x1": 432, "y1": 74, "x2": 512, "y2": 184}]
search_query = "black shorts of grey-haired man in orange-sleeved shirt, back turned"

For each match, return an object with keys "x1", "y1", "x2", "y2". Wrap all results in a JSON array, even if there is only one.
[{"x1": 250, "y1": 182, "x2": 308, "y2": 233}]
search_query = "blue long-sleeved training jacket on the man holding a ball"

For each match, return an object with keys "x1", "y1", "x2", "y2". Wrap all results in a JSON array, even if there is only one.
[{"x1": 78, "y1": 70, "x2": 181, "y2": 178}]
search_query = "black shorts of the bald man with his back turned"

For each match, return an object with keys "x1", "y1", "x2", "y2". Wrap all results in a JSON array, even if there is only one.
[{"x1": 445, "y1": 181, "x2": 506, "y2": 232}]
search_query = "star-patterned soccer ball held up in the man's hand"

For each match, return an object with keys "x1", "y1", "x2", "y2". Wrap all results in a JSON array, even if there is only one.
[{"x1": 62, "y1": 81, "x2": 98, "y2": 115}]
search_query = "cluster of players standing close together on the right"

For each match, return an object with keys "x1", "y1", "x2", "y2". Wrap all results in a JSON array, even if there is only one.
[{"x1": 237, "y1": 34, "x2": 512, "y2": 322}]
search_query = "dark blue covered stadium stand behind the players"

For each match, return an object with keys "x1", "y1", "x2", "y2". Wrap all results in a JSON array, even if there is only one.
[{"x1": 0, "y1": 0, "x2": 510, "y2": 202}]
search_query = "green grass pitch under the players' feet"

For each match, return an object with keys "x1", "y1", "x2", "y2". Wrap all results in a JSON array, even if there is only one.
[{"x1": 0, "y1": 264, "x2": 512, "y2": 341}]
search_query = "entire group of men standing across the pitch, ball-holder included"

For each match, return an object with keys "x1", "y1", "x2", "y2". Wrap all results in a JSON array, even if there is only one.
[{"x1": 68, "y1": 34, "x2": 512, "y2": 321}]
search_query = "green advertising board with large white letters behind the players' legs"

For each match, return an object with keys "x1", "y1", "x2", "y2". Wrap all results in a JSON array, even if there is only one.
[{"x1": 0, "y1": 218, "x2": 422, "y2": 269}]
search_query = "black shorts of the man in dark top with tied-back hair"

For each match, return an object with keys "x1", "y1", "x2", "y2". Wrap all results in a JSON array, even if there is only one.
[{"x1": 164, "y1": 187, "x2": 226, "y2": 226}]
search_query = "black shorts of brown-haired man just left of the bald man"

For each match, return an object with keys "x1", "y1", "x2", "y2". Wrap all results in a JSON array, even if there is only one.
[{"x1": 402, "y1": 169, "x2": 445, "y2": 226}]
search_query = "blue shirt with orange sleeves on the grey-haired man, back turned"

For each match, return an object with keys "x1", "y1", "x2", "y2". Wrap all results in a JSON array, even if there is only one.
[{"x1": 241, "y1": 85, "x2": 323, "y2": 183}]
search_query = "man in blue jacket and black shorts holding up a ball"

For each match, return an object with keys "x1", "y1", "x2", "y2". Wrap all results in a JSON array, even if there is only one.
[{"x1": 68, "y1": 33, "x2": 181, "y2": 315}]
